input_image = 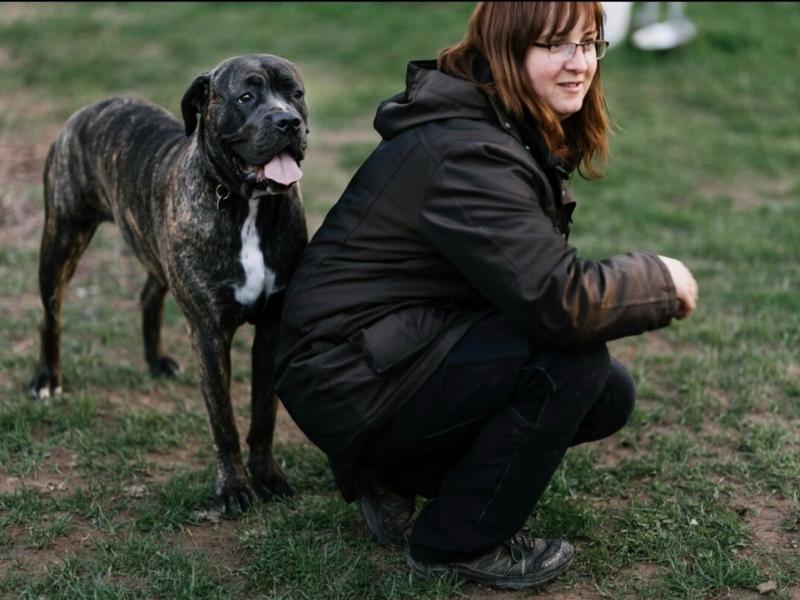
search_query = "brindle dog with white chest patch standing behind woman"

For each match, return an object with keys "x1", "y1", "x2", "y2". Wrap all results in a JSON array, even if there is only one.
[{"x1": 29, "y1": 54, "x2": 309, "y2": 516}]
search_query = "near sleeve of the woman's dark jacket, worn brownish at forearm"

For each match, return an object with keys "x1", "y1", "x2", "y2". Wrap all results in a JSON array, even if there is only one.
[{"x1": 419, "y1": 143, "x2": 678, "y2": 348}]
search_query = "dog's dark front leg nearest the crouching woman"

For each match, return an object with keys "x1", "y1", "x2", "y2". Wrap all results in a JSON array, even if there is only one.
[{"x1": 247, "y1": 310, "x2": 294, "y2": 499}]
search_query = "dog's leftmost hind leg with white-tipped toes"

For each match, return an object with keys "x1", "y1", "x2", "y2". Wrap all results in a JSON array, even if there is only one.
[{"x1": 28, "y1": 199, "x2": 100, "y2": 398}]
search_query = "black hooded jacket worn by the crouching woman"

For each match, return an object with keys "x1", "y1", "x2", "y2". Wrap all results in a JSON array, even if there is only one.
[{"x1": 277, "y1": 61, "x2": 677, "y2": 499}]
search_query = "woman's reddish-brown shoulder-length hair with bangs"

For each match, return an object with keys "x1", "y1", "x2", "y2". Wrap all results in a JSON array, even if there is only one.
[{"x1": 438, "y1": 2, "x2": 609, "y2": 178}]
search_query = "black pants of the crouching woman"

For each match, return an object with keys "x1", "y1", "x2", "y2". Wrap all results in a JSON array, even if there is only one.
[{"x1": 362, "y1": 316, "x2": 634, "y2": 563}]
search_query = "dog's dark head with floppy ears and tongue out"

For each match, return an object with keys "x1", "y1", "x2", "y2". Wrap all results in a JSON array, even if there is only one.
[{"x1": 181, "y1": 54, "x2": 308, "y2": 194}]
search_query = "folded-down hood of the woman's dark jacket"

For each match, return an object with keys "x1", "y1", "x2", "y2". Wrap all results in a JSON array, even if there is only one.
[{"x1": 374, "y1": 60, "x2": 497, "y2": 140}]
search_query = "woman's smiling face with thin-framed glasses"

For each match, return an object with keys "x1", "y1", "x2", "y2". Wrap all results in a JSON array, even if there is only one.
[{"x1": 525, "y1": 17, "x2": 598, "y2": 121}]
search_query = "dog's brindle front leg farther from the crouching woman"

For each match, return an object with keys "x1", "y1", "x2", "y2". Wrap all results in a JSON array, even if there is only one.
[{"x1": 190, "y1": 325, "x2": 255, "y2": 516}]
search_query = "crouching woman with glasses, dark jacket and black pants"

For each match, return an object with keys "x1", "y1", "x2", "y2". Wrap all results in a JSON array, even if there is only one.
[{"x1": 277, "y1": 2, "x2": 697, "y2": 588}]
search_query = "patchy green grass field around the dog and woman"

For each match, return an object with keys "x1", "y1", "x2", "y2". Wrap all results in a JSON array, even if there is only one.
[{"x1": 0, "y1": 3, "x2": 800, "y2": 600}]
